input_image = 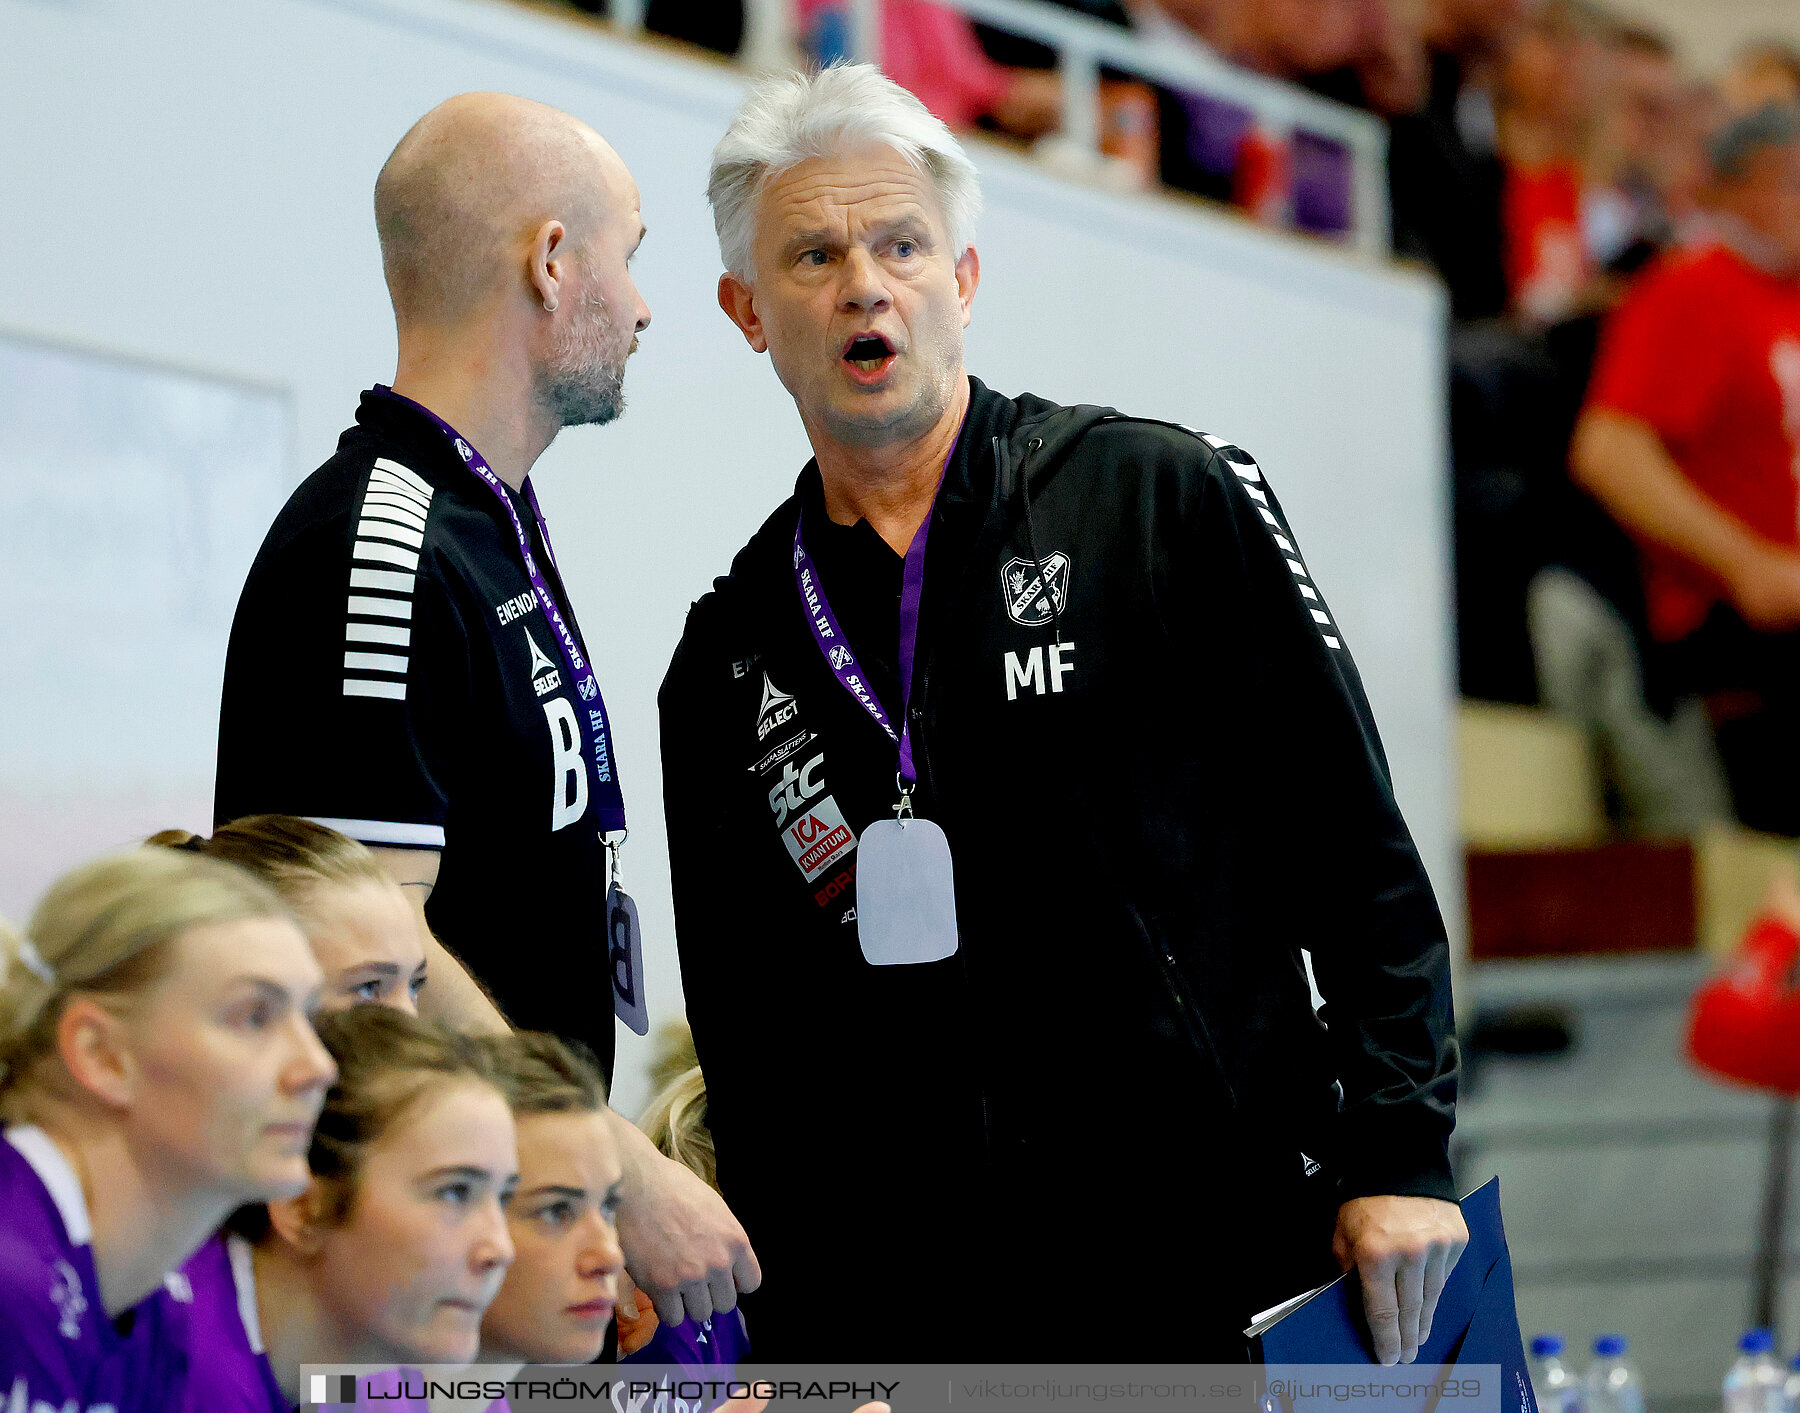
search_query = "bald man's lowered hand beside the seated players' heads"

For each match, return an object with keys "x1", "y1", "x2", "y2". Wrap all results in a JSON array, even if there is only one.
[{"x1": 612, "y1": 1114, "x2": 763, "y2": 1325}]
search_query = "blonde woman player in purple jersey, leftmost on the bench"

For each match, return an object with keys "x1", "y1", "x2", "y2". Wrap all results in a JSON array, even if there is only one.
[{"x1": 0, "y1": 850, "x2": 335, "y2": 1413}]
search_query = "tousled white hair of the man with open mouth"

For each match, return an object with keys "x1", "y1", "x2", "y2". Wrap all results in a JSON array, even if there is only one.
[{"x1": 706, "y1": 63, "x2": 981, "y2": 279}]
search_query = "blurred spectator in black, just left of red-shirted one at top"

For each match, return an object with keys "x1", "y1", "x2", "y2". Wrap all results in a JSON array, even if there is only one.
[{"x1": 1388, "y1": 0, "x2": 1526, "y2": 320}]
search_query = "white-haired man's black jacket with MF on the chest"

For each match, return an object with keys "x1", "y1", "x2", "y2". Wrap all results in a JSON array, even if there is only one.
[{"x1": 661, "y1": 380, "x2": 1458, "y2": 1359}]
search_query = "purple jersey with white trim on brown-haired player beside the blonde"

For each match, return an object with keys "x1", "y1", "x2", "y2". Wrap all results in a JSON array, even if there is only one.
[{"x1": 182, "y1": 1233, "x2": 292, "y2": 1413}]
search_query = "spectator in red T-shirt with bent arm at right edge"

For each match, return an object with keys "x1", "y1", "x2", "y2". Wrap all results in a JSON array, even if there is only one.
[{"x1": 1571, "y1": 108, "x2": 1800, "y2": 835}]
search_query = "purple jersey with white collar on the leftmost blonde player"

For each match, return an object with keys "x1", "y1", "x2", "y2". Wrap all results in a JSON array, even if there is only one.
[{"x1": 0, "y1": 1125, "x2": 189, "y2": 1413}]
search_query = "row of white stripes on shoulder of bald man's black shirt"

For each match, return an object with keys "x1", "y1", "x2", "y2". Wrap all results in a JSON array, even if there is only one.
[{"x1": 344, "y1": 457, "x2": 443, "y2": 698}]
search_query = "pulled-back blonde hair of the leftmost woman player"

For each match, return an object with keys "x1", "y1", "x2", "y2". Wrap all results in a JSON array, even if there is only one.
[{"x1": 0, "y1": 850, "x2": 292, "y2": 1121}]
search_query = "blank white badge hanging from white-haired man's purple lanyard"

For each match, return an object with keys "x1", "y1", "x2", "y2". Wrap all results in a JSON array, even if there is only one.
[{"x1": 857, "y1": 810, "x2": 956, "y2": 967}]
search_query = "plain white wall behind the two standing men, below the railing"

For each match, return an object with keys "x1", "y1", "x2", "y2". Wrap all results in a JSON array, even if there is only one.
[{"x1": 0, "y1": 0, "x2": 1462, "y2": 1103}]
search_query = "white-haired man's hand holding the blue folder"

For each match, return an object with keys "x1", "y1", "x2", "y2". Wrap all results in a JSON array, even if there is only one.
[{"x1": 1332, "y1": 1197, "x2": 1469, "y2": 1364}]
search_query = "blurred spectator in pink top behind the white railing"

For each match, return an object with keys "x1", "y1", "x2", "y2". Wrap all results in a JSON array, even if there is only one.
[{"x1": 797, "y1": 0, "x2": 1062, "y2": 139}]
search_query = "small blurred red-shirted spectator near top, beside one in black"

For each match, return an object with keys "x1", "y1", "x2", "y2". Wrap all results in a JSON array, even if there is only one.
[{"x1": 1499, "y1": 0, "x2": 1613, "y2": 324}]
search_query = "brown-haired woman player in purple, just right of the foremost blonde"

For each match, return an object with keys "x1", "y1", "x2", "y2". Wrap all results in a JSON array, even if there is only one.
[{"x1": 185, "y1": 1006, "x2": 518, "y2": 1413}]
